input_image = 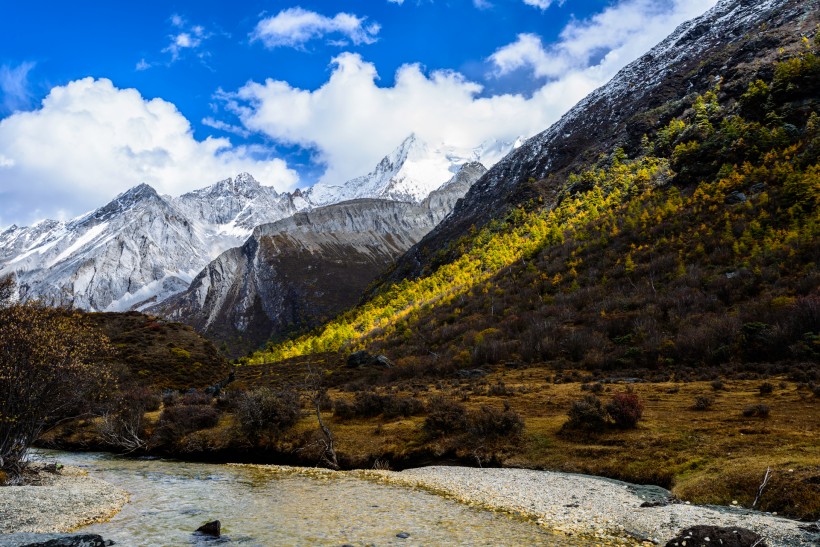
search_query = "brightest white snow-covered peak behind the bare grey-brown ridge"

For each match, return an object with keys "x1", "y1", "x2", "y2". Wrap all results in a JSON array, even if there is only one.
[{"x1": 306, "y1": 134, "x2": 521, "y2": 205}]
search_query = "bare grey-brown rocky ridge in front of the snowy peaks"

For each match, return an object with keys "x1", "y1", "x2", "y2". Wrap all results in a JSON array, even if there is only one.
[{"x1": 151, "y1": 163, "x2": 485, "y2": 354}]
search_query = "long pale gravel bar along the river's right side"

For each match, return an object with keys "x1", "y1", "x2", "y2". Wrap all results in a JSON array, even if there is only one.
[{"x1": 363, "y1": 466, "x2": 820, "y2": 547}]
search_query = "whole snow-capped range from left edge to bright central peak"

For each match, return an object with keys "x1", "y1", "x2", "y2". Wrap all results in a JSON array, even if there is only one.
[{"x1": 0, "y1": 133, "x2": 500, "y2": 311}]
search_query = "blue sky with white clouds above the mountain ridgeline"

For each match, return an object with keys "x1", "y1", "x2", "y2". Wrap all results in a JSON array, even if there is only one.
[{"x1": 0, "y1": 0, "x2": 715, "y2": 227}]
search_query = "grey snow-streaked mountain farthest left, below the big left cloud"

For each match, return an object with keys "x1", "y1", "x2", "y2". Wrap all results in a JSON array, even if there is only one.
[{"x1": 0, "y1": 184, "x2": 210, "y2": 310}]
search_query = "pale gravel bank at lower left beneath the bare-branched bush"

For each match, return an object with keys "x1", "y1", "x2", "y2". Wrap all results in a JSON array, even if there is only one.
[{"x1": 0, "y1": 463, "x2": 128, "y2": 544}]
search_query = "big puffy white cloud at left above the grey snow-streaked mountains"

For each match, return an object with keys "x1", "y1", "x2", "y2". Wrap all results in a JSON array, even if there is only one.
[{"x1": 0, "y1": 78, "x2": 298, "y2": 224}]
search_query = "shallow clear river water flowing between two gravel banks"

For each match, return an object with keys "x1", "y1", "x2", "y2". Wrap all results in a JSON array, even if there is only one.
[{"x1": 38, "y1": 451, "x2": 591, "y2": 546}]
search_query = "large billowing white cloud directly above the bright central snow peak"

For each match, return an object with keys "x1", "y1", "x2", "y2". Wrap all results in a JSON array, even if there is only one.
[{"x1": 227, "y1": 53, "x2": 594, "y2": 183}]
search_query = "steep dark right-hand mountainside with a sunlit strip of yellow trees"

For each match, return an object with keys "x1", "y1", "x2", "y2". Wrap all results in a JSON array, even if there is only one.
[{"x1": 250, "y1": 1, "x2": 820, "y2": 368}]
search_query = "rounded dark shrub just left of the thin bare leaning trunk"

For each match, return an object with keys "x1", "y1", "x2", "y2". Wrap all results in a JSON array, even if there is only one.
[{"x1": 234, "y1": 387, "x2": 302, "y2": 440}]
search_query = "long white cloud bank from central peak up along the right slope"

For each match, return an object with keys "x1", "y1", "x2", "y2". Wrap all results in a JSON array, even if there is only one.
[{"x1": 219, "y1": 0, "x2": 716, "y2": 183}]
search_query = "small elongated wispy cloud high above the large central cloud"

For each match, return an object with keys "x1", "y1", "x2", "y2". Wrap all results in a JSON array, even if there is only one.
[{"x1": 251, "y1": 7, "x2": 380, "y2": 48}]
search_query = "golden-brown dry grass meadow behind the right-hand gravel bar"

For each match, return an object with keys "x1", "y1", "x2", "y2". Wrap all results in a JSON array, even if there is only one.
[{"x1": 253, "y1": 368, "x2": 820, "y2": 518}]
